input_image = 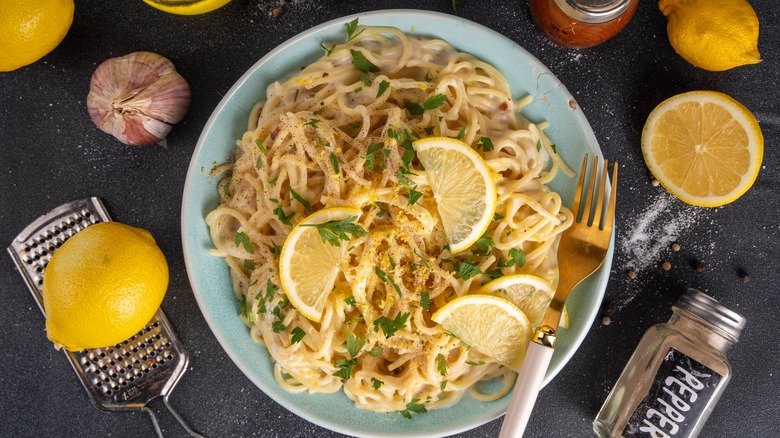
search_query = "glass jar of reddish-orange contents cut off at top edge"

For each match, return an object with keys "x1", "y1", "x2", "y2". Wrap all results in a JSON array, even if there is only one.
[{"x1": 530, "y1": 0, "x2": 639, "y2": 48}]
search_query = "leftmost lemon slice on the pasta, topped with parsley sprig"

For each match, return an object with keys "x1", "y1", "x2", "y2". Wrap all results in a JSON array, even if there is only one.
[{"x1": 279, "y1": 207, "x2": 361, "y2": 322}]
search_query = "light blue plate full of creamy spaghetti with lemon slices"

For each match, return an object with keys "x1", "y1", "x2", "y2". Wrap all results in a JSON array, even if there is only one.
[{"x1": 182, "y1": 10, "x2": 612, "y2": 437}]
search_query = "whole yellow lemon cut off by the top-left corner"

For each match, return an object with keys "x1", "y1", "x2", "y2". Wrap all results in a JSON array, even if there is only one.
[{"x1": 0, "y1": 0, "x2": 74, "y2": 72}]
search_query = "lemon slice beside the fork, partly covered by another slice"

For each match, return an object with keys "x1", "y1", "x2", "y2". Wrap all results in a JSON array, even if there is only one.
[{"x1": 478, "y1": 274, "x2": 555, "y2": 327}]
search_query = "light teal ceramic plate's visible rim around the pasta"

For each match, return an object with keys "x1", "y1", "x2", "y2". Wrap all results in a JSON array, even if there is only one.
[{"x1": 181, "y1": 10, "x2": 612, "y2": 437}]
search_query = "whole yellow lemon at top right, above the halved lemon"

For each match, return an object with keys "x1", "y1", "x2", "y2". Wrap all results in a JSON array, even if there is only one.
[{"x1": 658, "y1": 0, "x2": 761, "y2": 71}]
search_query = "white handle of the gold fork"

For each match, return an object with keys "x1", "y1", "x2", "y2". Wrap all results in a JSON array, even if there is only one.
[{"x1": 498, "y1": 342, "x2": 555, "y2": 438}]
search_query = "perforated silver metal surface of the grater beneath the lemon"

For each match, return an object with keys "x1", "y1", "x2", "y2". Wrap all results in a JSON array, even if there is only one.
[{"x1": 8, "y1": 197, "x2": 189, "y2": 410}]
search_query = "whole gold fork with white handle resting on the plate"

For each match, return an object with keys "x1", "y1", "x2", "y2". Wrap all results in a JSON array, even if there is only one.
[{"x1": 499, "y1": 155, "x2": 618, "y2": 438}]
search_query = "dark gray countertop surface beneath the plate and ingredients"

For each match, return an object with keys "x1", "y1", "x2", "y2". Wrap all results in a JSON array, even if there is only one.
[{"x1": 0, "y1": 0, "x2": 780, "y2": 437}]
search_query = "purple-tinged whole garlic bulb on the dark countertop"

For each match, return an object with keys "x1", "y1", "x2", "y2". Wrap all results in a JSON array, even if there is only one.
[{"x1": 87, "y1": 52, "x2": 190, "y2": 146}]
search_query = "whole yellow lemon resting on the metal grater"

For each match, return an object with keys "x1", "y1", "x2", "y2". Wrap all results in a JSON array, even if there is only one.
[{"x1": 42, "y1": 222, "x2": 168, "y2": 351}]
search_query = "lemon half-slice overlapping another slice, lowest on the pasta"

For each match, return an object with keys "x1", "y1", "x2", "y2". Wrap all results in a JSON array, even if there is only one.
[{"x1": 432, "y1": 294, "x2": 531, "y2": 371}]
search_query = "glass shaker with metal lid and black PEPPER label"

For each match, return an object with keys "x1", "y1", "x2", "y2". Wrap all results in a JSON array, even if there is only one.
[{"x1": 593, "y1": 289, "x2": 745, "y2": 438}]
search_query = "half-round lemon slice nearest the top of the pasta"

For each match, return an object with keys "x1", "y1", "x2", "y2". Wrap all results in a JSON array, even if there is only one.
[{"x1": 414, "y1": 137, "x2": 496, "y2": 254}]
